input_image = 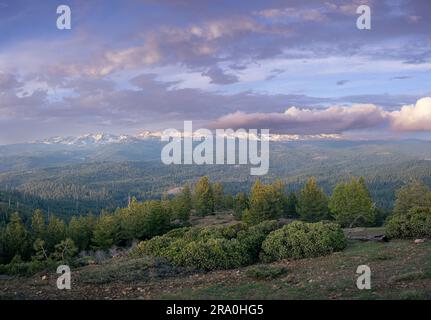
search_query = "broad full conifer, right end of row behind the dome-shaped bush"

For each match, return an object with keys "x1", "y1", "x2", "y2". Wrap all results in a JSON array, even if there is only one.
[{"x1": 329, "y1": 178, "x2": 375, "y2": 227}]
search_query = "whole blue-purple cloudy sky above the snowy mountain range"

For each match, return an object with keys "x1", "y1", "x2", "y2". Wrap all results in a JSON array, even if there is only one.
[{"x1": 0, "y1": 0, "x2": 431, "y2": 144}]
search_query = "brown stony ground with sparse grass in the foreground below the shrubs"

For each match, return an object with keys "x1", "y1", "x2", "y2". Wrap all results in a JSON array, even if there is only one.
[{"x1": 0, "y1": 230, "x2": 431, "y2": 299}]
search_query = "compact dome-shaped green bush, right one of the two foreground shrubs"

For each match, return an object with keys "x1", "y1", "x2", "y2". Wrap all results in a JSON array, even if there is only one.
[{"x1": 260, "y1": 221, "x2": 346, "y2": 262}]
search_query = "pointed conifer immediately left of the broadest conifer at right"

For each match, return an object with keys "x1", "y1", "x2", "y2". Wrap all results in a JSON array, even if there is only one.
[{"x1": 297, "y1": 178, "x2": 329, "y2": 222}]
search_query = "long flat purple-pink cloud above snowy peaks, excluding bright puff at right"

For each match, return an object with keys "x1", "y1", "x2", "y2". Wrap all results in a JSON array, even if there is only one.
[{"x1": 210, "y1": 104, "x2": 386, "y2": 134}]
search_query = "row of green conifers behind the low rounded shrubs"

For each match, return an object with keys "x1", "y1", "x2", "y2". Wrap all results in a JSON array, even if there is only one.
[{"x1": 0, "y1": 176, "x2": 431, "y2": 264}]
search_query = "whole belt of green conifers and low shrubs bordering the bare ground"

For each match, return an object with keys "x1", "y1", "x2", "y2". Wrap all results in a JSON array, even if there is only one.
[{"x1": 0, "y1": 176, "x2": 431, "y2": 274}]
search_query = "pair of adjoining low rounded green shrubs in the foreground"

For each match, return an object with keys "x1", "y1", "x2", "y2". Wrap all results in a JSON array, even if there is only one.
[{"x1": 133, "y1": 221, "x2": 346, "y2": 270}]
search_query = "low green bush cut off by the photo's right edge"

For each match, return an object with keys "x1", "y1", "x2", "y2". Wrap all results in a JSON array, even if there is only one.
[{"x1": 386, "y1": 208, "x2": 431, "y2": 239}]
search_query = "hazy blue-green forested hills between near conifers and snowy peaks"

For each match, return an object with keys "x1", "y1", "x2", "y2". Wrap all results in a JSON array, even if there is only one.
[{"x1": 0, "y1": 140, "x2": 431, "y2": 217}]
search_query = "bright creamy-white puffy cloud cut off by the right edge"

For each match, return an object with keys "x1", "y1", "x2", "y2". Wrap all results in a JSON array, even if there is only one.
[{"x1": 390, "y1": 97, "x2": 431, "y2": 131}]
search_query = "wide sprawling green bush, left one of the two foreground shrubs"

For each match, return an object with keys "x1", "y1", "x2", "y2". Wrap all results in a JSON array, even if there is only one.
[{"x1": 133, "y1": 221, "x2": 278, "y2": 270}]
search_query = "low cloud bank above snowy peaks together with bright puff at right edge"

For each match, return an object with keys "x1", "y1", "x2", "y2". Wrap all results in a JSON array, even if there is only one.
[{"x1": 210, "y1": 97, "x2": 431, "y2": 134}]
